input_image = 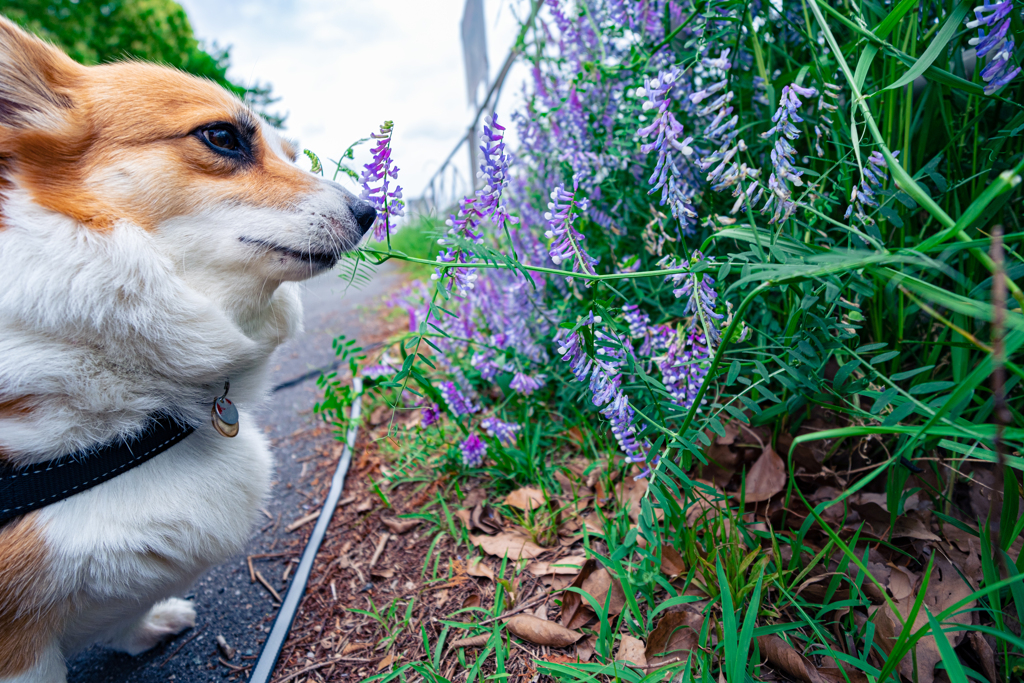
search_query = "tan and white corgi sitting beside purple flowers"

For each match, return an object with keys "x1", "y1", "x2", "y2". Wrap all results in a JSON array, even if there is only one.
[{"x1": 0, "y1": 17, "x2": 376, "y2": 683}]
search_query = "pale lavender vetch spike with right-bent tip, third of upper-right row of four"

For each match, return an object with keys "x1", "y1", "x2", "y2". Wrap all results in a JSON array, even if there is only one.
[{"x1": 761, "y1": 83, "x2": 818, "y2": 224}]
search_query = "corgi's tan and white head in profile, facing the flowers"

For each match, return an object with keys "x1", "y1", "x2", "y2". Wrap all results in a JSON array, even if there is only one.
[{"x1": 0, "y1": 17, "x2": 375, "y2": 283}]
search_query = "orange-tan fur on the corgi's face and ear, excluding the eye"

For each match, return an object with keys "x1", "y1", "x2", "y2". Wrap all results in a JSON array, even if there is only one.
[{"x1": 0, "y1": 17, "x2": 315, "y2": 230}]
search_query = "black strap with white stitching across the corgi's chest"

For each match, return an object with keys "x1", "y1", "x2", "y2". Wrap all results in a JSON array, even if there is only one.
[{"x1": 0, "y1": 415, "x2": 195, "y2": 524}]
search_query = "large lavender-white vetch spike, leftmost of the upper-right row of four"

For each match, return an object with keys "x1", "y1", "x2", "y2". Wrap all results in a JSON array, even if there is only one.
[{"x1": 637, "y1": 67, "x2": 697, "y2": 236}]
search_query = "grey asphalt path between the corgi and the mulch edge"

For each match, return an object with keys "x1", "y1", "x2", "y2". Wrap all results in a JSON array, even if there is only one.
[{"x1": 68, "y1": 263, "x2": 401, "y2": 683}]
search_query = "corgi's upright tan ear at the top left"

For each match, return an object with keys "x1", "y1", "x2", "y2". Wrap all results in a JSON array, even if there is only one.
[{"x1": 0, "y1": 16, "x2": 84, "y2": 130}]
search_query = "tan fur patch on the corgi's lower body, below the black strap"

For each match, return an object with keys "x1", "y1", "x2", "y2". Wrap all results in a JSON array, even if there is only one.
[{"x1": 0, "y1": 513, "x2": 62, "y2": 678}]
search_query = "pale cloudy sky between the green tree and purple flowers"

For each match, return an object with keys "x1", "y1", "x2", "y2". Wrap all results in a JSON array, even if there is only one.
[{"x1": 179, "y1": 0, "x2": 528, "y2": 204}]
